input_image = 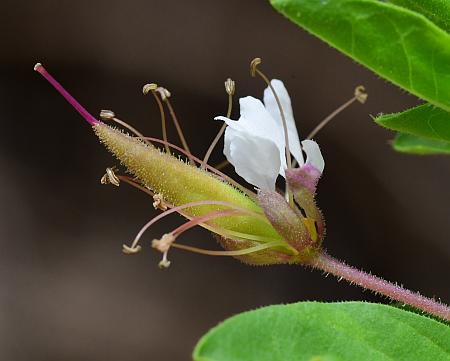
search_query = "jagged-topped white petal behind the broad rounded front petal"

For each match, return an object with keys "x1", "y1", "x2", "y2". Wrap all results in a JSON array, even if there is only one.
[{"x1": 214, "y1": 96, "x2": 287, "y2": 176}]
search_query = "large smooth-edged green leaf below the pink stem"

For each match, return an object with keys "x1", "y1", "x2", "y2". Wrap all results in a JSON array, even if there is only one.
[{"x1": 193, "y1": 302, "x2": 450, "y2": 361}]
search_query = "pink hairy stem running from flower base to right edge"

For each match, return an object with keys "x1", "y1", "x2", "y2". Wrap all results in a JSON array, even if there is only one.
[{"x1": 309, "y1": 252, "x2": 450, "y2": 321}]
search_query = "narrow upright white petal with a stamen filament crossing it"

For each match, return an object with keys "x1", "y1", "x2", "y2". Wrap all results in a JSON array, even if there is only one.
[{"x1": 264, "y1": 79, "x2": 304, "y2": 165}]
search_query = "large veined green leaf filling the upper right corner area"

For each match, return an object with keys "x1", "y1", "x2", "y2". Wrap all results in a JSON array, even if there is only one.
[{"x1": 271, "y1": 0, "x2": 450, "y2": 111}]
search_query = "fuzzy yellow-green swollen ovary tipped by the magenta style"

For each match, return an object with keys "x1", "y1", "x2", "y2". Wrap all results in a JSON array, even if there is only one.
[{"x1": 93, "y1": 123, "x2": 281, "y2": 240}]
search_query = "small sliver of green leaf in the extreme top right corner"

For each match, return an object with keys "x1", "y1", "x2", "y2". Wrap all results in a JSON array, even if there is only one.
[{"x1": 389, "y1": 0, "x2": 450, "y2": 32}]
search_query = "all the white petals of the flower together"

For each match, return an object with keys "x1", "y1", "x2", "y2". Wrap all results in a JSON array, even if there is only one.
[{"x1": 214, "y1": 79, "x2": 325, "y2": 190}]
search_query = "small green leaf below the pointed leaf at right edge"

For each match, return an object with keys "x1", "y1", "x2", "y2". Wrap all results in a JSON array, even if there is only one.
[{"x1": 392, "y1": 133, "x2": 450, "y2": 155}]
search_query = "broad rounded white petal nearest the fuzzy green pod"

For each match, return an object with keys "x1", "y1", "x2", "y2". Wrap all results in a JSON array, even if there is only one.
[{"x1": 224, "y1": 127, "x2": 280, "y2": 191}]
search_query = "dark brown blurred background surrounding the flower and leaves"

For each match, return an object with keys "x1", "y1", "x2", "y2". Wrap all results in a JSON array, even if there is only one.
[{"x1": 0, "y1": 0, "x2": 450, "y2": 361}]
